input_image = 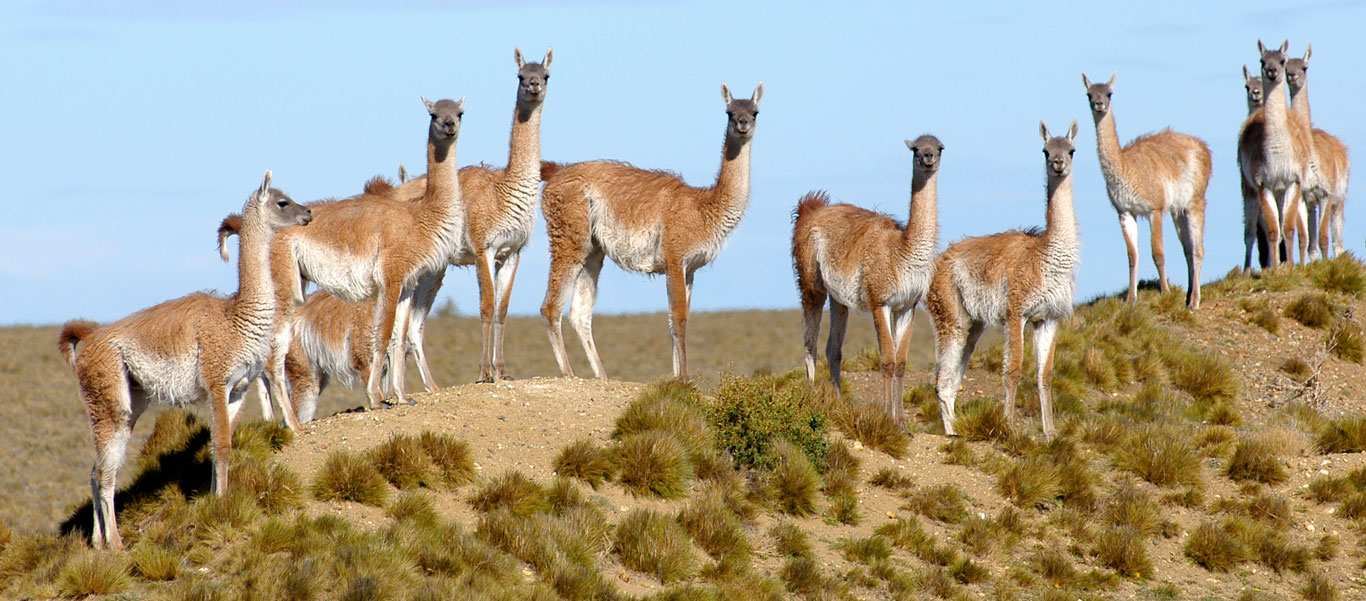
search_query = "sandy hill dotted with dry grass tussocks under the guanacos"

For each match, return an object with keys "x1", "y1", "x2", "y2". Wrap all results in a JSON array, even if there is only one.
[{"x1": 0, "y1": 260, "x2": 1366, "y2": 600}]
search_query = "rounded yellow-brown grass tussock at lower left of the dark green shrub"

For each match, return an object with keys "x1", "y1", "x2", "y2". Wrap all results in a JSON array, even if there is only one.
[{"x1": 613, "y1": 430, "x2": 693, "y2": 499}]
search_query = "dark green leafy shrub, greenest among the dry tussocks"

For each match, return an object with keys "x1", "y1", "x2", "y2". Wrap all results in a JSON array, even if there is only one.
[{"x1": 708, "y1": 374, "x2": 829, "y2": 469}]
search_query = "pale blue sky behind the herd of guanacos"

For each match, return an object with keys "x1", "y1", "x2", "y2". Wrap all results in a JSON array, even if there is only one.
[{"x1": 0, "y1": 0, "x2": 1366, "y2": 324}]
